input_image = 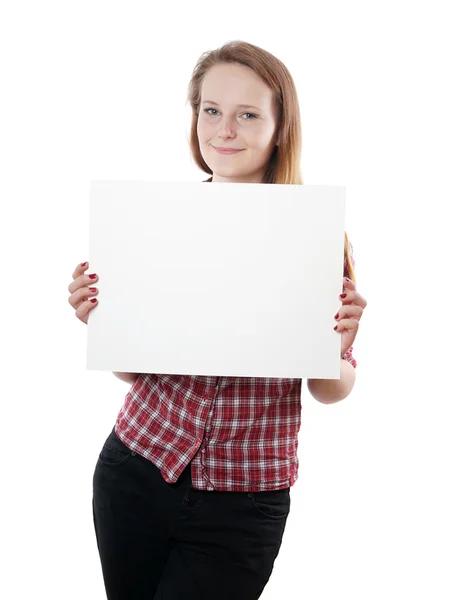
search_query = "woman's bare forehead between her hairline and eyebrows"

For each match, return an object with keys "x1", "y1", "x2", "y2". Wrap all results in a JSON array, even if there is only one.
[{"x1": 202, "y1": 64, "x2": 272, "y2": 108}]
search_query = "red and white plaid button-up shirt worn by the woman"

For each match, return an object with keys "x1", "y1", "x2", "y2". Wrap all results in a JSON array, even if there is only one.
[{"x1": 115, "y1": 178, "x2": 356, "y2": 492}]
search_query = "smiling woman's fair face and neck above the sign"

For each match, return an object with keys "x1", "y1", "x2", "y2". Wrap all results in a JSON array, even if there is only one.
[{"x1": 197, "y1": 64, "x2": 277, "y2": 183}]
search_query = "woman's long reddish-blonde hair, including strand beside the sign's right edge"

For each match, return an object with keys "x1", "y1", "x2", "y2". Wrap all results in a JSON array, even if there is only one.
[{"x1": 187, "y1": 40, "x2": 356, "y2": 283}]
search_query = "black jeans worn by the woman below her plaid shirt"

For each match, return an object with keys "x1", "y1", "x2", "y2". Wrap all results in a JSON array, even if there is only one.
[{"x1": 92, "y1": 428, "x2": 290, "y2": 600}]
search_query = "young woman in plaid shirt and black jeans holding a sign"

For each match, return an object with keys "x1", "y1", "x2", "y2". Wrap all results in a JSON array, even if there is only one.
[{"x1": 69, "y1": 42, "x2": 367, "y2": 600}]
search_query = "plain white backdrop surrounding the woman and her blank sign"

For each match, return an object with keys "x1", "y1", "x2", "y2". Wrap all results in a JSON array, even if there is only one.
[{"x1": 0, "y1": 0, "x2": 450, "y2": 600}]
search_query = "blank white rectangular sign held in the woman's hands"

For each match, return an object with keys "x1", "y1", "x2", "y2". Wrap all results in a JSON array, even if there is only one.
[{"x1": 87, "y1": 181, "x2": 345, "y2": 379}]
